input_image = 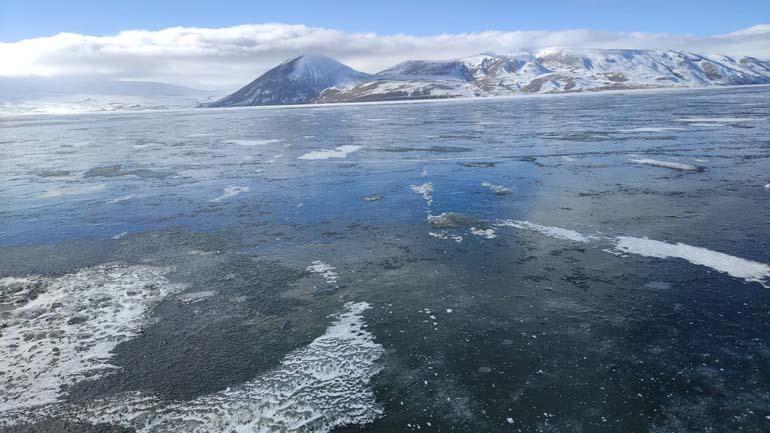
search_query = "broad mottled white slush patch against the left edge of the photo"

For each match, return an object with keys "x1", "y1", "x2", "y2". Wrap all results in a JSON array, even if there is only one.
[{"x1": 0, "y1": 265, "x2": 182, "y2": 417}]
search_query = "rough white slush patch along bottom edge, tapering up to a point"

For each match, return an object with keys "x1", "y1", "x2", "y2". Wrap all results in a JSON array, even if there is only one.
[{"x1": 0, "y1": 302, "x2": 384, "y2": 433}]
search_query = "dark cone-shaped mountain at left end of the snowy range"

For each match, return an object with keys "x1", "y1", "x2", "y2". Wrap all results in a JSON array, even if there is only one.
[{"x1": 207, "y1": 54, "x2": 372, "y2": 107}]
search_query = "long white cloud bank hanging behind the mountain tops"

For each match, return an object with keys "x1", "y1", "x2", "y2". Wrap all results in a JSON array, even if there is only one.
[{"x1": 0, "y1": 24, "x2": 770, "y2": 89}]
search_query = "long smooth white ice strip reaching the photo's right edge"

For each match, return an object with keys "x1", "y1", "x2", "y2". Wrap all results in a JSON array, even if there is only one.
[{"x1": 614, "y1": 236, "x2": 770, "y2": 287}]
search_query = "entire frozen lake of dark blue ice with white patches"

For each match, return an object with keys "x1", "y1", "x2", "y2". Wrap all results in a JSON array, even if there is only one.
[{"x1": 0, "y1": 87, "x2": 770, "y2": 433}]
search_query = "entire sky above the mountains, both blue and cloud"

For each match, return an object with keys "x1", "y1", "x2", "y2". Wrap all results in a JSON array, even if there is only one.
[{"x1": 0, "y1": 0, "x2": 770, "y2": 89}]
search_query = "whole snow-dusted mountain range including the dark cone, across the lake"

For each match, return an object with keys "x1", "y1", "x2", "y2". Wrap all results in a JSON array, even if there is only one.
[{"x1": 210, "y1": 48, "x2": 770, "y2": 106}]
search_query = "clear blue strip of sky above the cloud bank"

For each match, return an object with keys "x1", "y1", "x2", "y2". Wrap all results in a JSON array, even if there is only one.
[{"x1": 0, "y1": 0, "x2": 770, "y2": 42}]
